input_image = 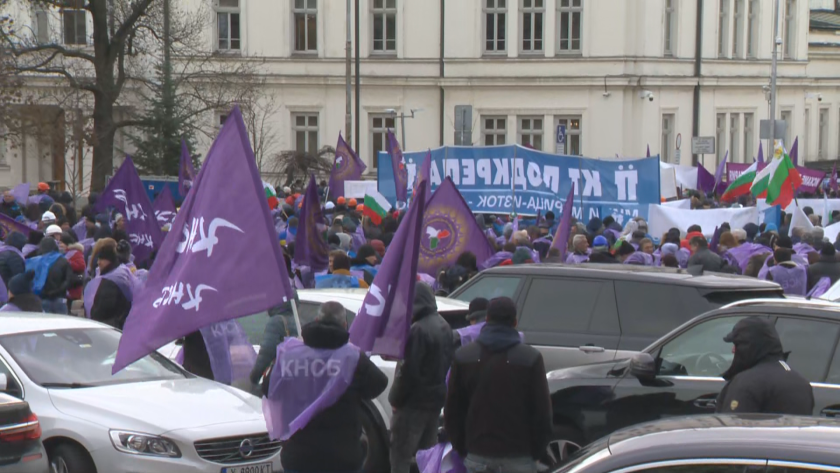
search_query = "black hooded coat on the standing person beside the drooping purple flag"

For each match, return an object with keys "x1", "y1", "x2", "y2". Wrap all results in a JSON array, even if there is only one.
[{"x1": 388, "y1": 283, "x2": 455, "y2": 411}]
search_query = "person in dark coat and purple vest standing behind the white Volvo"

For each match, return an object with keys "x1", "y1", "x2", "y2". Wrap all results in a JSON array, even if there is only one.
[{"x1": 84, "y1": 238, "x2": 133, "y2": 330}]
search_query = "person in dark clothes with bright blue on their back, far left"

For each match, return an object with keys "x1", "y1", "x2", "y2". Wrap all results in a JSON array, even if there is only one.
[{"x1": 26, "y1": 238, "x2": 73, "y2": 315}]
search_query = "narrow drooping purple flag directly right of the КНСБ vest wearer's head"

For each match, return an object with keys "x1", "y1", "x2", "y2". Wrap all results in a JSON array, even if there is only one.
[{"x1": 350, "y1": 181, "x2": 426, "y2": 359}]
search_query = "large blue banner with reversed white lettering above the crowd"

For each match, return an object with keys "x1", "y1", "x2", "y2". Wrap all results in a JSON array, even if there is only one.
[{"x1": 377, "y1": 145, "x2": 660, "y2": 222}]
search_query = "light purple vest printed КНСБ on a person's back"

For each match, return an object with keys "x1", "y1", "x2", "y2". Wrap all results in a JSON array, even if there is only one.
[{"x1": 263, "y1": 338, "x2": 360, "y2": 440}]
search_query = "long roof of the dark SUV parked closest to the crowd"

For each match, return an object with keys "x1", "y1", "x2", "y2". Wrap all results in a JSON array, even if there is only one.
[{"x1": 482, "y1": 263, "x2": 781, "y2": 290}]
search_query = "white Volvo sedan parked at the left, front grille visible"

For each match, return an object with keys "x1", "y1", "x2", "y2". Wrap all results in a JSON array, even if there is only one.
[{"x1": 0, "y1": 312, "x2": 281, "y2": 473}]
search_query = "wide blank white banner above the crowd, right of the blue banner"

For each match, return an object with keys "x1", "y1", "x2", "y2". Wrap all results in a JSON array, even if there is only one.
[{"x1": 648, "y1": 205, "x2": 758, "y2": 238}]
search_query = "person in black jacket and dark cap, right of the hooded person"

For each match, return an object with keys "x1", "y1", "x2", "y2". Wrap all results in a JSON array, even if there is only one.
[{"x1": 443, "y1": 297, "x2": 552, "y2": 473}]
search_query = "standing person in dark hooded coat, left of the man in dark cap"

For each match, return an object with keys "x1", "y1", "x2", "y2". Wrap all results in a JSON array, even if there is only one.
[{"x1": 388, "y1": 282, "x2": 455, "y2": 473}]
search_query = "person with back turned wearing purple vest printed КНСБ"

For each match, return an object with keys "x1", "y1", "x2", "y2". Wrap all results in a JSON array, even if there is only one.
[{"x1": 263, "y1": 302, "x2": 388, "y2": 473}]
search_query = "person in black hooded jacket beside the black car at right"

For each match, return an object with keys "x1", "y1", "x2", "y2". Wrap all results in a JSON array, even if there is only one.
[{"x1": 716, "y1": 317, "x2": 814, "y2": 416}]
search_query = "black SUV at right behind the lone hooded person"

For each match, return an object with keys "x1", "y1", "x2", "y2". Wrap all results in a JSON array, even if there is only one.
[{"x1": 548, "y1": 299, "x2": 840, "y2": 460}]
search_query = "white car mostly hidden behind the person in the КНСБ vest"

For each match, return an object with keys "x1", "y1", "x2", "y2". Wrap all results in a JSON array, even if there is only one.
[{"x1": 159, "y1": 289, "x2": 469, "y2": 472}]
